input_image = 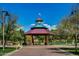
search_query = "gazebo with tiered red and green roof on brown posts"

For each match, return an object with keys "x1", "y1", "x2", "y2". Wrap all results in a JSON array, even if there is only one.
[{"x1": 25, "y1": 17, "x2": 50, "y2": 45}]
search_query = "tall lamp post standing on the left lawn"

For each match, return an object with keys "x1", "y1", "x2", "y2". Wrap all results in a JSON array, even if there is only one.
[{"x1": 2, "y1": 11, "x2": 9, "y2": 51}]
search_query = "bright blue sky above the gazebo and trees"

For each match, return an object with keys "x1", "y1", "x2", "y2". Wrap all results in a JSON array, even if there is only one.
[{"x1": 0, "y1": 3, "x2": 74, "y2": 31}]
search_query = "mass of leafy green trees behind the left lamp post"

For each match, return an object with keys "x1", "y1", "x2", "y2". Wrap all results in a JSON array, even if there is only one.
[{"x1": 0, "y1": 8, "x2": 24, "y2": 48}]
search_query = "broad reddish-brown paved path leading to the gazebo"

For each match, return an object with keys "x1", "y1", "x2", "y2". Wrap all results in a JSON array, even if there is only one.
[{"x1": 10, "y1": 46, "x2": 73, "y2": 56}]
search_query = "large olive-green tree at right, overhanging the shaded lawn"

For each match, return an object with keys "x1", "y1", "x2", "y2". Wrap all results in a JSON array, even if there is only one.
[{"x1": 60, "y1": 5, "x2": 79, "y2": 52}]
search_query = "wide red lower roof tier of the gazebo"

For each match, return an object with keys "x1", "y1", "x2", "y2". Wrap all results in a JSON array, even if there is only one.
[{"x1": 25, "y1": 29, "x2": 49, "y2": 34}]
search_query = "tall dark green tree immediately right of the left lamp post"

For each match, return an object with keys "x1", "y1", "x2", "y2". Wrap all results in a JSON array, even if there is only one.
[{"x1": 5, "y1": 15, "x2": 17, "y2": 44}]
